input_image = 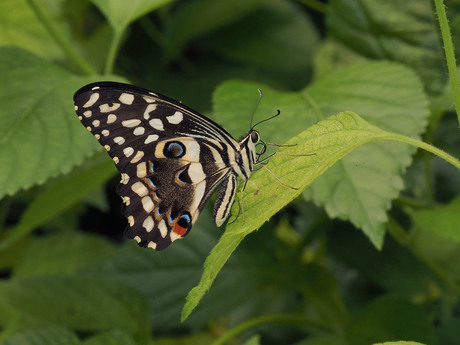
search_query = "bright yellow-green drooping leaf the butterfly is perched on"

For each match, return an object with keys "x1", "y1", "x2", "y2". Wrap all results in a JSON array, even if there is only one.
[{"x1": 182, "y1": 112, "x2": 410, "y2": 319}]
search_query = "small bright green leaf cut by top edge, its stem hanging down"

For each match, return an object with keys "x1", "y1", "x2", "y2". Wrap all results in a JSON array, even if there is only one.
[{"x1": 91, "y1": 0, "x2": 172, "y2": 33}]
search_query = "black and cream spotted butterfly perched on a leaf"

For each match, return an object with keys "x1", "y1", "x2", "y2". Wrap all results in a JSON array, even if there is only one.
[{"x1": 74, "y1": 82, "x2": 276, "y2": 250}]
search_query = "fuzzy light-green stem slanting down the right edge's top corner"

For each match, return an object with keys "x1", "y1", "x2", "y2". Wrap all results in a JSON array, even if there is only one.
[{"x1": 434, "y1": 0, "x2": 460, "y2": 124}]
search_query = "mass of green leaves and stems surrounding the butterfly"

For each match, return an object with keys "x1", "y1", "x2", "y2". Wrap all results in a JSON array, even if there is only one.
[{"x1": 0, "y1": 0, "x2": 460, "y2": 345}]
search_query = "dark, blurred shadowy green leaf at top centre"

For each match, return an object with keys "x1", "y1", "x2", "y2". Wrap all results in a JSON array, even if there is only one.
[{"x1": 211, "y1": 1, "x2": 318, "y2": 73}]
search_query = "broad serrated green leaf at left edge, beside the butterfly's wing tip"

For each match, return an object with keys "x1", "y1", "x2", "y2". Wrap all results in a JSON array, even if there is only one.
[{"x1": 0, "y1": 48, "x2": 107, "y2": 197}]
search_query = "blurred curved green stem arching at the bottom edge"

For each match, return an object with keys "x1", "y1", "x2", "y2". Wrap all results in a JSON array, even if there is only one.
[{"x1": 211, "y1": 314, "x2": 317, "y2": 345}]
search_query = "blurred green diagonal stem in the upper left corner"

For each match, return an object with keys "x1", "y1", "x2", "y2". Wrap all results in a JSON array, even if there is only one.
[{"x1": 27, "y1": 0, "x2": 97, "y2": 75}]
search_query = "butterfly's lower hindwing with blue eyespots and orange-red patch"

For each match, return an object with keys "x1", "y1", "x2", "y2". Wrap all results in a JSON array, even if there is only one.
[{"x1": 113, "y1": 138, "x2": 229, "y2": 249}]
